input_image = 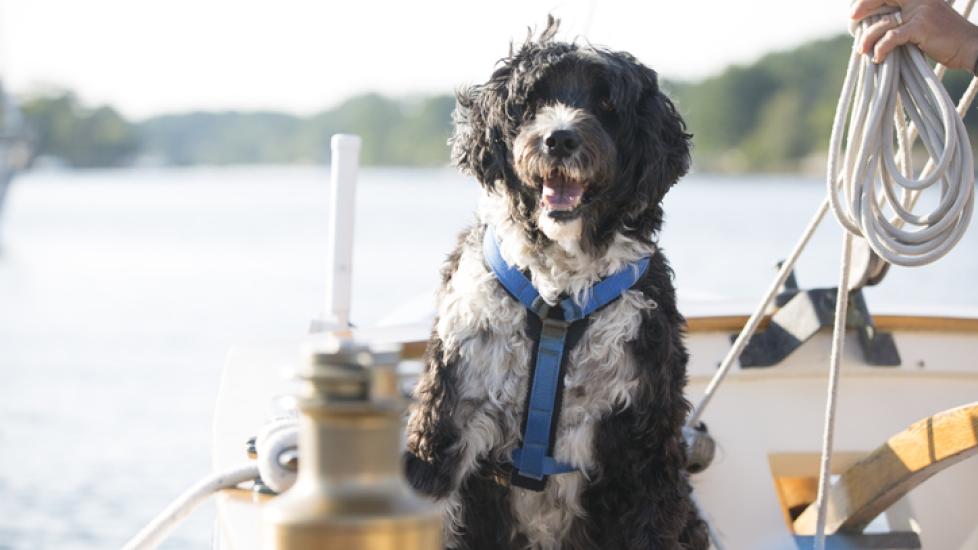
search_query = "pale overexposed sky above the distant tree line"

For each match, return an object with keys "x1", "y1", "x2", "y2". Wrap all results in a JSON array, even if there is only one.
[{"x1": 0, "y1": 0, "x2": 849, "y2": 118}]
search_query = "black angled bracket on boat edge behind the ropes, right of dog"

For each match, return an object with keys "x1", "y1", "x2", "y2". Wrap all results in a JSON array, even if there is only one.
[{"x1": 731, "y1": 266, "x2": 900, "y2": 368}]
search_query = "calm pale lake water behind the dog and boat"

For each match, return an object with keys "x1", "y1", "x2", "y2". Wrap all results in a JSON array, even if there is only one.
[{"x1": 0, "y1": 168, "x2": 978, "y2": 549}]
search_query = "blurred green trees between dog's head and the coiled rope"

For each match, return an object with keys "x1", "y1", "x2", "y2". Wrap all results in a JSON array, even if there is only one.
[{"x1": 667, "y1": 35, "x2": 978, "y2": 173}]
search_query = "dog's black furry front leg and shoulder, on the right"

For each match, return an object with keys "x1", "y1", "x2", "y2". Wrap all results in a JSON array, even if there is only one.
[{"x1": 567, "y1": 292, "x2": 709, "y2": 550}]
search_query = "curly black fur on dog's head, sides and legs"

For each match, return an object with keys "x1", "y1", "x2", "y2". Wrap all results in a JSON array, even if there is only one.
[{"x1": 405, "y1": 20, "x2": 708, "y2": 550}]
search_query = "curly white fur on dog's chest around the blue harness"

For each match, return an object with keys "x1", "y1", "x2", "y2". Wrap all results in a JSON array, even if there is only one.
[{"x1": 436, "y1": 196, "x2": 656, "y2": 549}]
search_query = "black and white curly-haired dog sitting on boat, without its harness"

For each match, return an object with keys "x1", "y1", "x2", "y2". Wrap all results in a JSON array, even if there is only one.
[{"x1": 405, "y1": 19, "x2": 708, "y2": 550}]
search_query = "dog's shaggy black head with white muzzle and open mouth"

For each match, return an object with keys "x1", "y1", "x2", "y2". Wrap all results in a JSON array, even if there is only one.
[{"x1": 452, "y1": 20, "x2": 691, "y2": 253}]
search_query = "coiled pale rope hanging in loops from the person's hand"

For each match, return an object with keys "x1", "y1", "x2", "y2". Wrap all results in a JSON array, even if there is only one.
[{"x1": 828, "y1": 10, "x2": 974, "y2": 266}]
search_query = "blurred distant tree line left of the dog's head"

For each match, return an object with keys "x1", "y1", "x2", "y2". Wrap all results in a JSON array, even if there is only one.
[{"x1": 21, "y1": 91, "x2": 454, "y2": 167}]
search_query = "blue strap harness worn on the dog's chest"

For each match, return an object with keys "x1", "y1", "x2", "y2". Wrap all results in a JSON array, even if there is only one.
[{"x1": 482, "y1": 226, "x2": 649, "y2": 491}]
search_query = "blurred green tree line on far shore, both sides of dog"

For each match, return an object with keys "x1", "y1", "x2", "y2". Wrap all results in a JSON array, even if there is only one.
[{"x1": 22, "y1": 35, "x2": 978, "y2": 172}]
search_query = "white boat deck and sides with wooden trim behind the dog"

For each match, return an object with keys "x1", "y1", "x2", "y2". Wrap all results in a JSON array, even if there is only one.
[{"x1": 214, "y1": 316, "x2": 978, "y2": 550}]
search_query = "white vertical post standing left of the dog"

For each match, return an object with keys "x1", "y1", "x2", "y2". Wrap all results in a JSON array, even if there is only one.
[{"x1": 313, "y1": 134, "x2": 360, "y2": 332}]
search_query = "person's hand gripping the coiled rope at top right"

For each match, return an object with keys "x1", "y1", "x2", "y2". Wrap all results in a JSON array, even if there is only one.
[{"x1": 850, "y1": 0, "x2": 978, "y2": 72}]
